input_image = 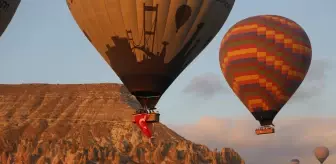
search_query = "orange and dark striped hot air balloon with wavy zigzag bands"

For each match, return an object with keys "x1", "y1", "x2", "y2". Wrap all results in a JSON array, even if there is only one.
[{"x1": 219, "y1": 15, "x2": 312, "y2": 135}]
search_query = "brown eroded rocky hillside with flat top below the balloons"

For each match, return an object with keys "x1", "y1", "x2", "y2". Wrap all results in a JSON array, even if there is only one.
[{"x1": 0, "y1": 84, "x2": 244, "y2": 164}]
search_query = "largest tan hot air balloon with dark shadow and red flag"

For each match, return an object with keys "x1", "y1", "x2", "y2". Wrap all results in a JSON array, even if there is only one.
[{"x1": 67, "y1": 0, "x2": 234, "y2": 137}]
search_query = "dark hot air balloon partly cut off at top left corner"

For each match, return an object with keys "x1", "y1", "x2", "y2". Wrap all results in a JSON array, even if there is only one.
[{"x1": 0, "y1": 0, "x2": 21, "y2": 36}]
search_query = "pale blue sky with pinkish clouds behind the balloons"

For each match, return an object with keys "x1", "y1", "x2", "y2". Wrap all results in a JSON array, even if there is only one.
[{"x1": 0, "y1": 0, "x2": 336, "y2": 164}]
